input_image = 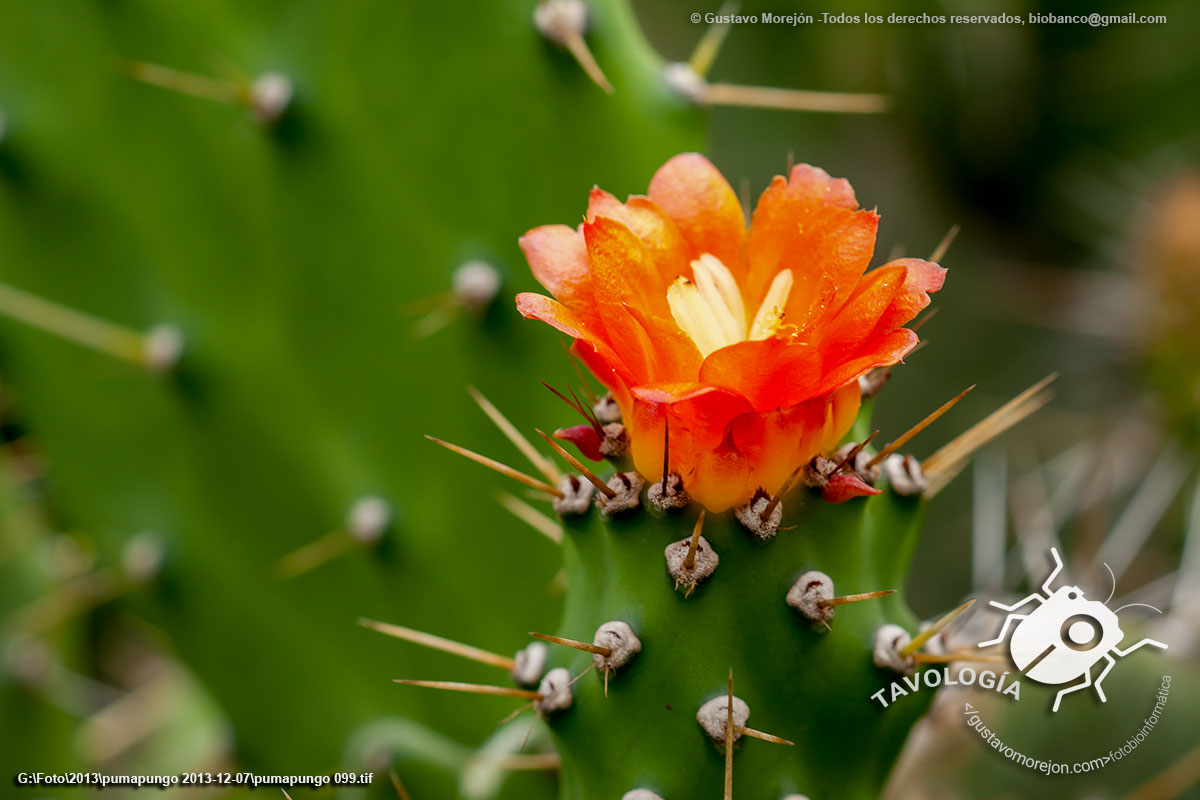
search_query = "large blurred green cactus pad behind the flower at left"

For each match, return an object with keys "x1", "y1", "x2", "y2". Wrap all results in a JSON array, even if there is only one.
[{"x1": 0, "y1": 0, "x2": 704, "y2": 796}]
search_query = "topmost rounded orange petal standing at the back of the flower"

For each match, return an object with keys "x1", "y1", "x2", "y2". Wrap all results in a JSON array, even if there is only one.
[{"x1": 649, "y1": 152, "x2": 746, "y2": 277}]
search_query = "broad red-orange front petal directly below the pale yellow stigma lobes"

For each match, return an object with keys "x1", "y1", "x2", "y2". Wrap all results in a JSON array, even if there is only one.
[{"x1": 700, "y1": 337, "x2": 821, "y2": 411}]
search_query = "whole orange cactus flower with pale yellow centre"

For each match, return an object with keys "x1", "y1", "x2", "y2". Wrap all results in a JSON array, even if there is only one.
[{"x1": 517, "y1": 154, "x2": 946, "y2": 511}]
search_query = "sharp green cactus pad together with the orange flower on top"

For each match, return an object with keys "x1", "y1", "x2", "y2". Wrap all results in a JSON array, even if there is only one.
[{"x1": 501, "y1": 154, "x2": 944, "y2": 800}]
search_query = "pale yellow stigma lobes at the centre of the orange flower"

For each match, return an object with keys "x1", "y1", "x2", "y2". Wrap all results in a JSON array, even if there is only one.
[{"x1": 667, "y1": 253, "x2": 792, "y2": 356}]
